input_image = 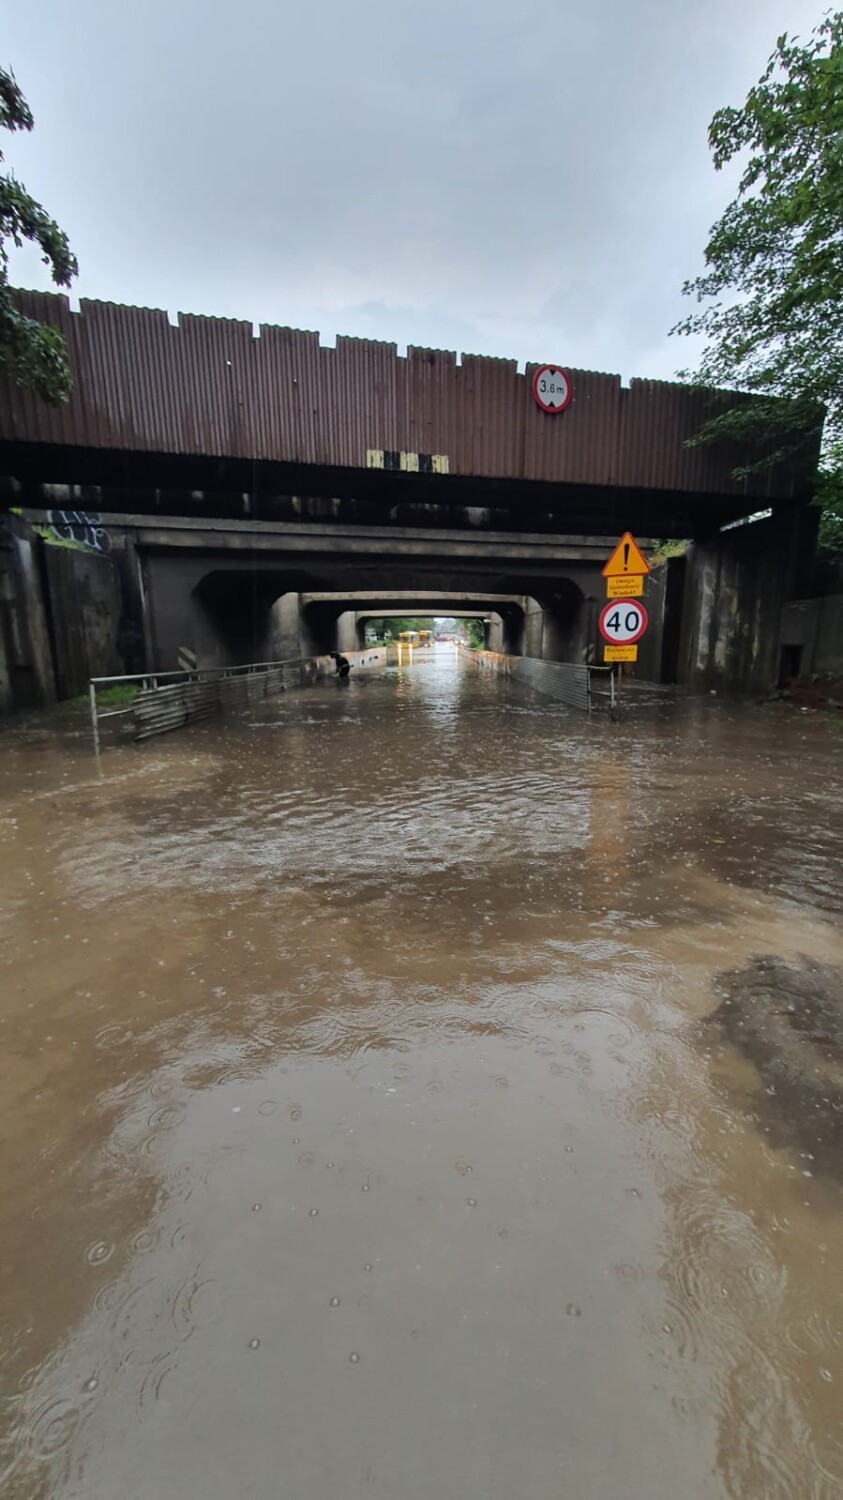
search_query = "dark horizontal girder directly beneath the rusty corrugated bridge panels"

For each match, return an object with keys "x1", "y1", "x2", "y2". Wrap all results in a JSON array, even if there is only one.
[{"x1": 0, "y1": 441, "x2": 798, "y2": 539}]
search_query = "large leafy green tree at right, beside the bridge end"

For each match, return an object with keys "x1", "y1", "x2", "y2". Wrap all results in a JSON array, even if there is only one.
[{"x1": 672, "y1": 11, "x2": 843, "y2": 552}]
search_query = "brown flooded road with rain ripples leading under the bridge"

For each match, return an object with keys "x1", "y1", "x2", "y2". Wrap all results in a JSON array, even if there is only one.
[{"x1": 0, "y1": 650, "x2": 843, "y2": 1500}]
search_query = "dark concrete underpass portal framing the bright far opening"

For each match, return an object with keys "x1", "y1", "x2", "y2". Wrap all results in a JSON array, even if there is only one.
[{"x1": 104, "y1": 516, "x2": 606, "y2": 669}]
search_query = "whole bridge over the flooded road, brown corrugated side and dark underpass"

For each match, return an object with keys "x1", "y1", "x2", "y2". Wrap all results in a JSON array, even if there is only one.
[{"x1": 0, "y1": 294, "x2": 816, "y2": 689}]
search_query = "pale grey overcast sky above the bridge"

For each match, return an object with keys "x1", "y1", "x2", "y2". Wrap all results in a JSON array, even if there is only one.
[{"x1": 2, "y1": 0, "x2": 827, "y2": 380}]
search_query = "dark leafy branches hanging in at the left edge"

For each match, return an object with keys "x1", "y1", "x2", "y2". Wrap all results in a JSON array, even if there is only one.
[{"x1": 0, "y1": 68, "x2": 78, "y2": 404}]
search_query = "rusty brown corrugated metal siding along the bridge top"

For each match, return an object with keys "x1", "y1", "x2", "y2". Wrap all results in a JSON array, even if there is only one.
[{"x1": 0, "y1": 293, "x2": 797, "y2": 498}]
